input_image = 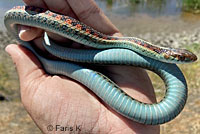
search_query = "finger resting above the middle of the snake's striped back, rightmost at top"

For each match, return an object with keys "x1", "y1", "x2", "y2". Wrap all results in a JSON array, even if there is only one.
[{"x1": 67, "y1": 0, "x2": 119, "y2": 35}]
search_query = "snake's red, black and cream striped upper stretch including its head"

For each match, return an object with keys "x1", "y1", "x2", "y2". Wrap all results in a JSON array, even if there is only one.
[{"x1": 6, "y1": 6, "x2": 197, "y2": 63}]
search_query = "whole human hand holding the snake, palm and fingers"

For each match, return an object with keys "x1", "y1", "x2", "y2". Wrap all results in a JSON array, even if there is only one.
[{"x1": 6, "y1": 0, "x2": 160, "y2": 134}]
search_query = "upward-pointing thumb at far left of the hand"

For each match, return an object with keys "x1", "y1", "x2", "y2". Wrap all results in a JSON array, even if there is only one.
[{"x1": 6, "y1": 44, "x2": 44, "y2": 84}]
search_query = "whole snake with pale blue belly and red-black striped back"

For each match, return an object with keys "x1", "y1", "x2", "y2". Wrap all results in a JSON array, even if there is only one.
[{"x1": 4, "y1": 6, "x2": 197, "y2": 125}]
